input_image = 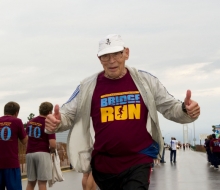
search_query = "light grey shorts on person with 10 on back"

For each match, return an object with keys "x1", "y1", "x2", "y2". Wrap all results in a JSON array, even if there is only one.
[{"x1": 26, "y1": 152, "x2": 52, "y2": 181}]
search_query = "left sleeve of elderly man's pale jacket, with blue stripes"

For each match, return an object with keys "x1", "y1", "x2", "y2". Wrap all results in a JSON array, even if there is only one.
[{"x1": 56, "y1": 86, "x2": 80, "y2": 132}]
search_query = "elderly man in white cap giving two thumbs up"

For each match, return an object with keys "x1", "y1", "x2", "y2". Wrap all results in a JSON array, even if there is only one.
[{"x1": 46, "y1": 34, "x2": 200, "y2": 190}]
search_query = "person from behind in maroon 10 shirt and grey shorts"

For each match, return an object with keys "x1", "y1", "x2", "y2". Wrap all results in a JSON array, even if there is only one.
[{"x1": 26, "y1": 102, "x2": 56, "y2": 190}]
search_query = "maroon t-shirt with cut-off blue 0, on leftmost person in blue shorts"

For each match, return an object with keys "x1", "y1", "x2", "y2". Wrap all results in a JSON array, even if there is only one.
[{"x1": 0, "y1": 116, "x2": 26, "y2": 169}]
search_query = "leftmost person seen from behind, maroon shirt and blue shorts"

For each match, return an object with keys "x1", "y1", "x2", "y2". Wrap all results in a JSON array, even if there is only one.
[{"x1": 0, "y1": 102, "x2": 28, "y2": 190}]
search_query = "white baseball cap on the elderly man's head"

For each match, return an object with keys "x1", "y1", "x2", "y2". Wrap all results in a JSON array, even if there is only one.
[{"x1": 98, "y1": 34, "x2": 125, "y2": 56}]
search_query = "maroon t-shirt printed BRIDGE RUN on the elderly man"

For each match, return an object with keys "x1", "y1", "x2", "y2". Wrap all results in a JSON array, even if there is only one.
[{"x1": 91, "y1": 72, "x2": 153, "y2": 174}]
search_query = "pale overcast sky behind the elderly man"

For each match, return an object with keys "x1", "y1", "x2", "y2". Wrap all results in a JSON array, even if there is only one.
[{"x1": 0, "y1": 0, "x2": 220, "y2": 143}]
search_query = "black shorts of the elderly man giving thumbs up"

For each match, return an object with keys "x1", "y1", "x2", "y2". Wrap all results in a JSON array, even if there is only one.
[{"x1": 92, "y1": 164, "x2": 151, "y2": 190}]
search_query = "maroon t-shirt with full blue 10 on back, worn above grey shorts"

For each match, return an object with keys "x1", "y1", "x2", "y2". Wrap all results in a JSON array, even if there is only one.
[{"x1": 26, "y1": 116, "x2": 56, "y2": 154}]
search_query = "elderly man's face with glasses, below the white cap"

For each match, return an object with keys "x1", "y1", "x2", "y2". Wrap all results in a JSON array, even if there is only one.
[{"x1": 99, "y1": 48, "x2": 129, "y2": 78}]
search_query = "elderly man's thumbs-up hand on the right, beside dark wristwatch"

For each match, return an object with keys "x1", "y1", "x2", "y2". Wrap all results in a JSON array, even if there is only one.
[{"x1": 184, "y1": 90, "x2": 200, "y2": 118}]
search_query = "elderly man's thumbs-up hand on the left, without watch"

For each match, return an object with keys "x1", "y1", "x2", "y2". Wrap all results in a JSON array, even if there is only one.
[{"x1": 45, "y1": 104, "x2": 61, "y2": 132}]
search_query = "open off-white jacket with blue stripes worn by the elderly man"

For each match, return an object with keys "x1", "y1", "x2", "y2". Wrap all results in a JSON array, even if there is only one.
[{"x1": 52, "y1": 66, "x2": 195, "y2": 173}]
